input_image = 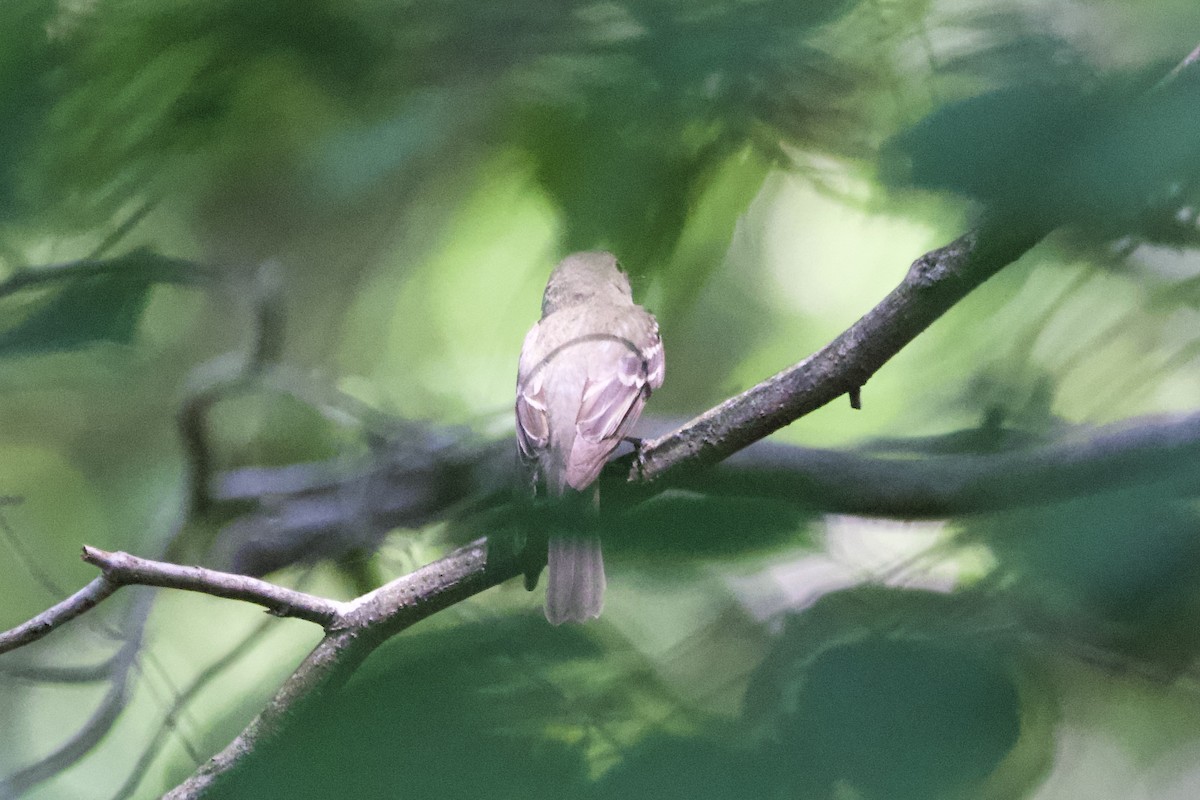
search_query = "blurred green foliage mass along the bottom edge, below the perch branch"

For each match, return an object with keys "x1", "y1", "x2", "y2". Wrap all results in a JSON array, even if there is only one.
[{"x1": 199, "y1": 591, "x2": 1048, "y2": 800}]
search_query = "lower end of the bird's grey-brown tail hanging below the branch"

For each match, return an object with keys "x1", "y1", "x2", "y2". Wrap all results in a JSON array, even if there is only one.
[{"x1": 546, "y1": 533, "x2": 606, "y2": 625}]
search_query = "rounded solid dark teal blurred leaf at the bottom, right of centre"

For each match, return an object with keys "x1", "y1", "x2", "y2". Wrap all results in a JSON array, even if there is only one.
[{"x1": 776, "y1": 637, "x2": 1021, "y2": 800}]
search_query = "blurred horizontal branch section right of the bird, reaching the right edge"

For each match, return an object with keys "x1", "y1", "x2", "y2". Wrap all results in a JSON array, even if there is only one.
[{"x1": 700, "y1": 414, "x2": 1200, "y2": 519}]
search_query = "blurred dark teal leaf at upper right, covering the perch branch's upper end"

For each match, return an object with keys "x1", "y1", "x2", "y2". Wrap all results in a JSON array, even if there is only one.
[{"x1": 884, "y1": 65, "x2": 1200, "y2": 244}]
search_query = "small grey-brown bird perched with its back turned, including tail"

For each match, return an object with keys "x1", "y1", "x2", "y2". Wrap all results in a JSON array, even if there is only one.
[{"x1": 516, "y1": 252, "x2": 664, "y2": 625}]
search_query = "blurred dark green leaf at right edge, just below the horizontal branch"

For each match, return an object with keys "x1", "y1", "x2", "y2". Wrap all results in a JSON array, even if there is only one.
[{"x1": 967, "y1": 488, "x2": 1200, "y2": 672}]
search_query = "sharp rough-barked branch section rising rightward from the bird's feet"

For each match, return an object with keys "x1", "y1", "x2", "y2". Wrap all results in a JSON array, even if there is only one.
[{"x1": 630, "y1": 219, "x2": 1049, "y2": 481}]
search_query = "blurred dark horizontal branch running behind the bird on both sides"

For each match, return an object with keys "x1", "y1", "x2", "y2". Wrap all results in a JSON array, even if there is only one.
[{"x1": 206, "y1": 414, "x2": 1200, "y2": 548}]
